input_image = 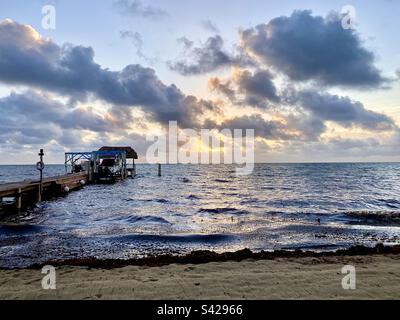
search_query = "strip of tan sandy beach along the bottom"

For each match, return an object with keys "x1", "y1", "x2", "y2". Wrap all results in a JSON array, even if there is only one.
[{"x1": 0, "y1": 254, "x2": 400, "y2": 299}]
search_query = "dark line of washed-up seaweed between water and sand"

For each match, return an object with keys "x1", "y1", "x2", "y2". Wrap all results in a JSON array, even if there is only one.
[{"x1": 0, "y1": 244, "x2": 400, "y2": 271}]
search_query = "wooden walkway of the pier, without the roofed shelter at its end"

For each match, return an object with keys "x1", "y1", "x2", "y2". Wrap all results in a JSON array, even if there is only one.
[{"x1": 0, "y1": 172, "x2": 89, "y2": 210}]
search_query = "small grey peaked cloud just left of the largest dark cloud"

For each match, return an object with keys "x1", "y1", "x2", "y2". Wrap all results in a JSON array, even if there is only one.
[{"x1": 168, "y1": 35, "x2": 250, "y2": 75}]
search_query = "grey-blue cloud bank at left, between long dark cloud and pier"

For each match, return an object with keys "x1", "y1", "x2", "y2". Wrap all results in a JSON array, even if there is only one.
[{"x1": 0, "y1": 91, "x2": 115, "y2": 145}]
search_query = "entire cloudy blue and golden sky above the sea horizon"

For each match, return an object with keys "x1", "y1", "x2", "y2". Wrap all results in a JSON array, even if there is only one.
[{"x1": 0, "y1": 0, "x2": 400, "y2": 164}]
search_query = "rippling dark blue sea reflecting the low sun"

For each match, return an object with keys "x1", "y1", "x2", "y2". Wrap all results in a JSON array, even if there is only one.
[{"x1": 0, "y1": 163, "x2": 400, "y2": 267}]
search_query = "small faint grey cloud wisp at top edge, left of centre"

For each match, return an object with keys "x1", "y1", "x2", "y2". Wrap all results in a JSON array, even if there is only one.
[{"x1": 113, "y1": 0, "x2": 168, "y2": 18}]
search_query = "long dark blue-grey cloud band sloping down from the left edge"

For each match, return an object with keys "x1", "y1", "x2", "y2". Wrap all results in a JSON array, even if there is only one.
[{"x1": 0, "y1": 21, "x2": 216, "y2": 127}]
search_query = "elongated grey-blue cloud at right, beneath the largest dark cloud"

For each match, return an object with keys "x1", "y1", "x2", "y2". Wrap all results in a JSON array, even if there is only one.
[{"x1": 292, "y1": 91, "x2": 396, "y2": 131}]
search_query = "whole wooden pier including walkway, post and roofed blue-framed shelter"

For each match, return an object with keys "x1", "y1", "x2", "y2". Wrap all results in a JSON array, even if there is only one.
[{"x1": 0, "y1": 147, "x2": 138, "y2": 212}]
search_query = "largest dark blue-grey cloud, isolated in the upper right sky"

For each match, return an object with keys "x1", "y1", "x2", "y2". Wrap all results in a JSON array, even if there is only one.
[{"x1": 241, "y1": 11, "x2": 387, "y2": 88}]
